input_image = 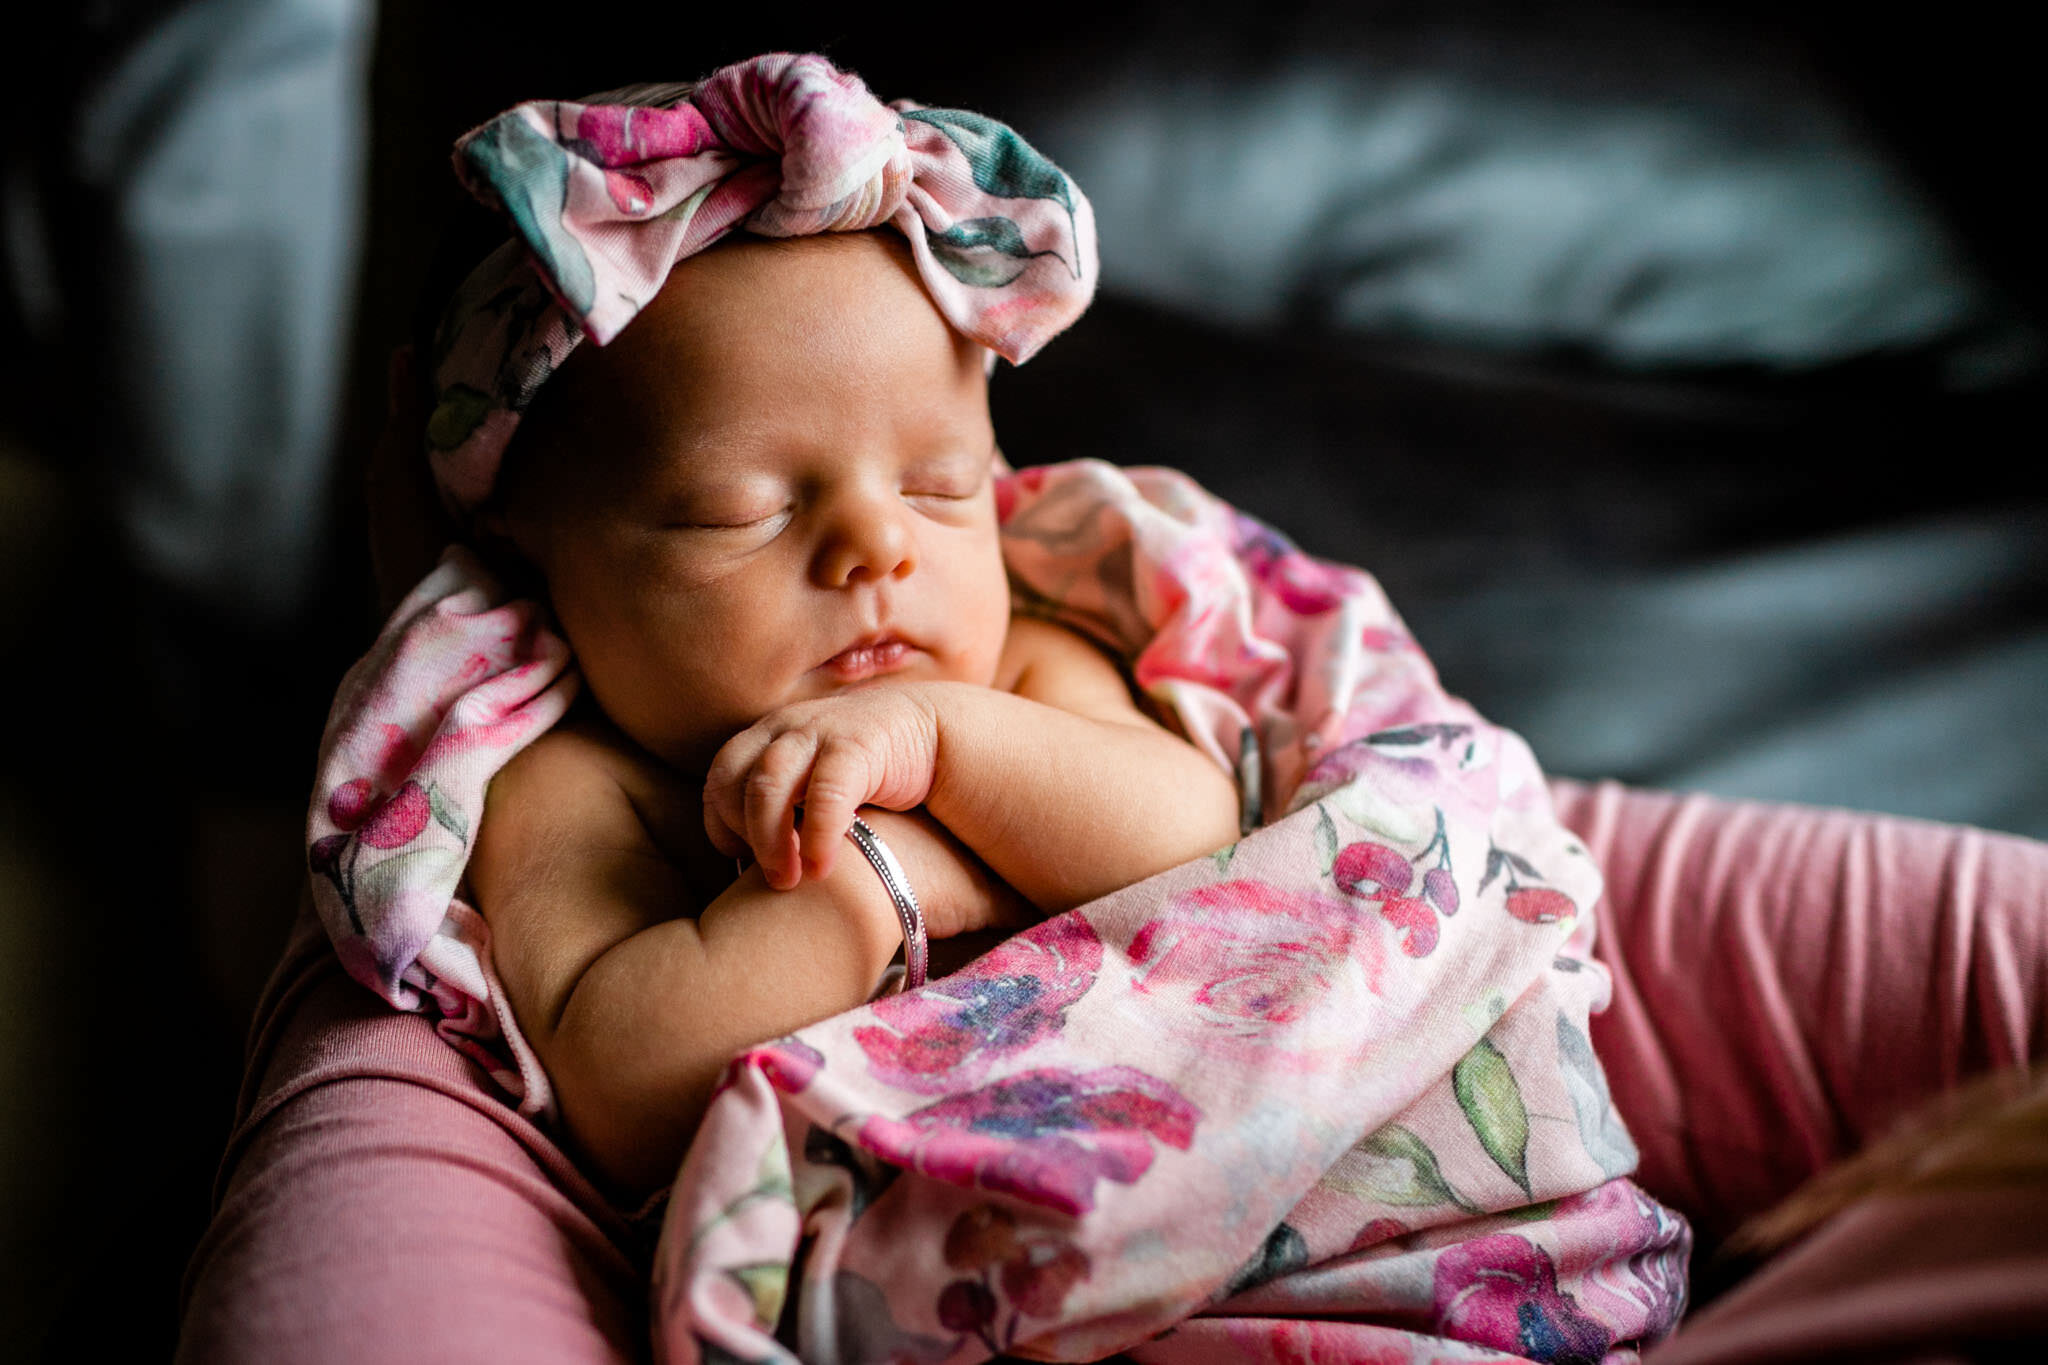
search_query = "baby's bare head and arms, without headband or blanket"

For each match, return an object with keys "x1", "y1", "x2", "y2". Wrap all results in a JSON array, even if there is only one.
[{"x1": 469, "y1": 231, "x2": 1237, "y2": 1193}]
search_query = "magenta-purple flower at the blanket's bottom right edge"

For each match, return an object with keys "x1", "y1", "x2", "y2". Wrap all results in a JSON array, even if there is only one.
[{"x1": 1434, "y1": 1232, "x2": 1614, "y2": 1365}]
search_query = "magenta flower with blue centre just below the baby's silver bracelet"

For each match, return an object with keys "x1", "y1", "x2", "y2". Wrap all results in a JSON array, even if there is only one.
[{"x1": 854, "y1": 915, "x2": 1102, "y2": 1095}]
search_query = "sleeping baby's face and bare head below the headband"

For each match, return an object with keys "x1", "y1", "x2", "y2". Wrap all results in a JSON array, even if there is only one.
[{"x1": 504, "y1": 233, "x2": 1010, "y2": 772}]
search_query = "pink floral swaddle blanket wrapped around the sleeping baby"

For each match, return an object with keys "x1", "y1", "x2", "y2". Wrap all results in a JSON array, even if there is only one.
[{"x1": 309, "y1": 463, "x2": 1690, "y2": 1361}]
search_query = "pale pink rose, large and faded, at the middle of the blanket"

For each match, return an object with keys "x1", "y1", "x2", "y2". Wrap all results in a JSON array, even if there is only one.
[{"x1": 1130, "y1": 879, "x2": 1368, "y2": 1038}]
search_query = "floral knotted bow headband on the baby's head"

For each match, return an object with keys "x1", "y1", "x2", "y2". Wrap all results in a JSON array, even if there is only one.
[{"x1": 426, "y1": 53, "x2": 1096, "y2": 518}]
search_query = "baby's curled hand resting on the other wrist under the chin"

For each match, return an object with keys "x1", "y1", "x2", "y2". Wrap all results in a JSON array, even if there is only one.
[{"x1": 705, "y1": 684, "x2": 938, "y2": 890}]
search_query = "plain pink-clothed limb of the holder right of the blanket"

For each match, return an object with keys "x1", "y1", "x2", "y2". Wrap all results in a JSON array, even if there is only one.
[{"x1": 1552, "y1": 782, "x2": 2048, "y2": 1248}]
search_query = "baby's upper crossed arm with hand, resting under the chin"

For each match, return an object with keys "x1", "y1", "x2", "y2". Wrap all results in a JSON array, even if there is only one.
[{"x1": 705, "y1": 620, "x2": 1237, "y2": 913}]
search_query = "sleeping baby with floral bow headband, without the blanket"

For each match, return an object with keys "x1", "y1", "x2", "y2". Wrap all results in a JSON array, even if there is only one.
[{"x1": 399, "y1": 57, "x2": 1239, "y2": 1195}]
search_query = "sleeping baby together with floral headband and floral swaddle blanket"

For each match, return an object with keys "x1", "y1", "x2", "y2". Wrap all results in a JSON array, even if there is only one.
[{"x1": 307, "y1": 55, "x2": 1688, "y2": 1361}]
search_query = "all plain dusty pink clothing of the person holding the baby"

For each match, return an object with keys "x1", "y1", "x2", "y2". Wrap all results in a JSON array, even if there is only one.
[{"x1": 180, "y1": 782, "x2": 2048, "y2": 1365}]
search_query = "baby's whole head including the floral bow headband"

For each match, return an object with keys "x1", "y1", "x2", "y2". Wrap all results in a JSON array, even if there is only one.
[{"x1": 428, "y1": 53, "x2": 1096, "y2": 767}]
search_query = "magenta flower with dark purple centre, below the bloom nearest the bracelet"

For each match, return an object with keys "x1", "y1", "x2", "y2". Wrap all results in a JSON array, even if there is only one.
[{"x1": 858, "y1": 1066, "x2": 1200, "y2": 1214}]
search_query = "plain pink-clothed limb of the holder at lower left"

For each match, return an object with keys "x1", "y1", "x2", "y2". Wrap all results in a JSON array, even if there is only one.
[{"x1": 178, "y1": 900, "x2": 649, "y2": 1365}]
